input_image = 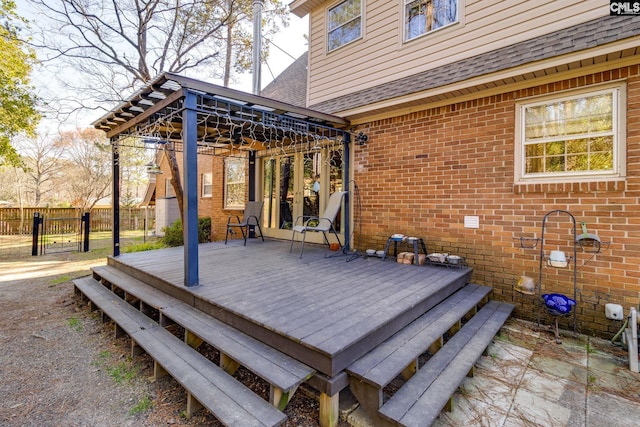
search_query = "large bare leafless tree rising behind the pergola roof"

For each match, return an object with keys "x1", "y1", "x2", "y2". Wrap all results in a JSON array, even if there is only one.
[{"x1": 31, "y1": 0, "x2": 286, "y2": 221}]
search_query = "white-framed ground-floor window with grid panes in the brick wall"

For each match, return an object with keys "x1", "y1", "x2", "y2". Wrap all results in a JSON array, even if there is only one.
[{"x1": 516, "y1": 85, "x2": 625, "y2": 181}]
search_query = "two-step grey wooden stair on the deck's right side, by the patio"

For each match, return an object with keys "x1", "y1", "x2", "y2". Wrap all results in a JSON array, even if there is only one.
[{"x1": 347, "y1": 284, "x2": 514, "y2": 426}]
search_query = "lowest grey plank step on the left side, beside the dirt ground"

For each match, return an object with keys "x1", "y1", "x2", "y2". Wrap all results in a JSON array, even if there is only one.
[{"x1": 74, "y1": 277, "x2": 287, "y2": 426}]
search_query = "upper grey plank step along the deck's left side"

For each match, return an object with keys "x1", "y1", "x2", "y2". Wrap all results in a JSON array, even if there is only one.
[{"x1": 94, "y1": 266, "x2": 315, "y2": 409}]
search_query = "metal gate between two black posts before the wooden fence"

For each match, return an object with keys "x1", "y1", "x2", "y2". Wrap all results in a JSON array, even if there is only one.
[{"x1": 31, "y1": 212, "x2": 90, "y2": 256}]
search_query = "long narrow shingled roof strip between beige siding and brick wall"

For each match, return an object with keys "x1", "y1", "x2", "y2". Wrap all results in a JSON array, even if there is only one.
[{"x1": 309, "y1": 16, "x2": 640, "y2": 119}]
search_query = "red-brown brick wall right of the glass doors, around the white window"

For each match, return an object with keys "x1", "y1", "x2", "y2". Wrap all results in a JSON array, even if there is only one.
[{"x1": 354, "y1": 66, "x2": 640, "y2": 337}]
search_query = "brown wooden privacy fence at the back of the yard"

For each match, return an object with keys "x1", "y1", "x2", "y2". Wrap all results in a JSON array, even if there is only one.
[{"x1": 0, "y1": 208, "x2": 155, "y2": 236}]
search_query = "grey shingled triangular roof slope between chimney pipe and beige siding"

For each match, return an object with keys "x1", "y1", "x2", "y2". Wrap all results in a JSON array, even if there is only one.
[{"x1": 260, "y1": 52, "x2": 309, "y2": 107}]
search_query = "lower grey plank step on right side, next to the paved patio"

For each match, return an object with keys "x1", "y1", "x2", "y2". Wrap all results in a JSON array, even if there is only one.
[{"x1": 379, "y1": 301, "x2": 514, "y2": 426}]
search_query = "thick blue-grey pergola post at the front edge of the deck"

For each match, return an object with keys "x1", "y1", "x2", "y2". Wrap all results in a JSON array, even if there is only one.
[{"x1": 182, "y1": 90, "x2": 200, "y2": 287}]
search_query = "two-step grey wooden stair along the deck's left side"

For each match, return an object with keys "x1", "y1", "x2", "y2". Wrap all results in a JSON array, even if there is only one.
[{"x1": 74, "y1": 266, "x2": 315, "y2": 426}]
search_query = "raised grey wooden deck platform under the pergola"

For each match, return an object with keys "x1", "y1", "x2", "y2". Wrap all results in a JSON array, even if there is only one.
[{"x1": 108, "y1": 239, "x2": 471, "y2": 377}]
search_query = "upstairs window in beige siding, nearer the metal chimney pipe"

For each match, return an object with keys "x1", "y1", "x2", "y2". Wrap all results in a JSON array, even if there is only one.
[{"x1": 327, "y1": 0, "x2": 362, "y2": 51}]
